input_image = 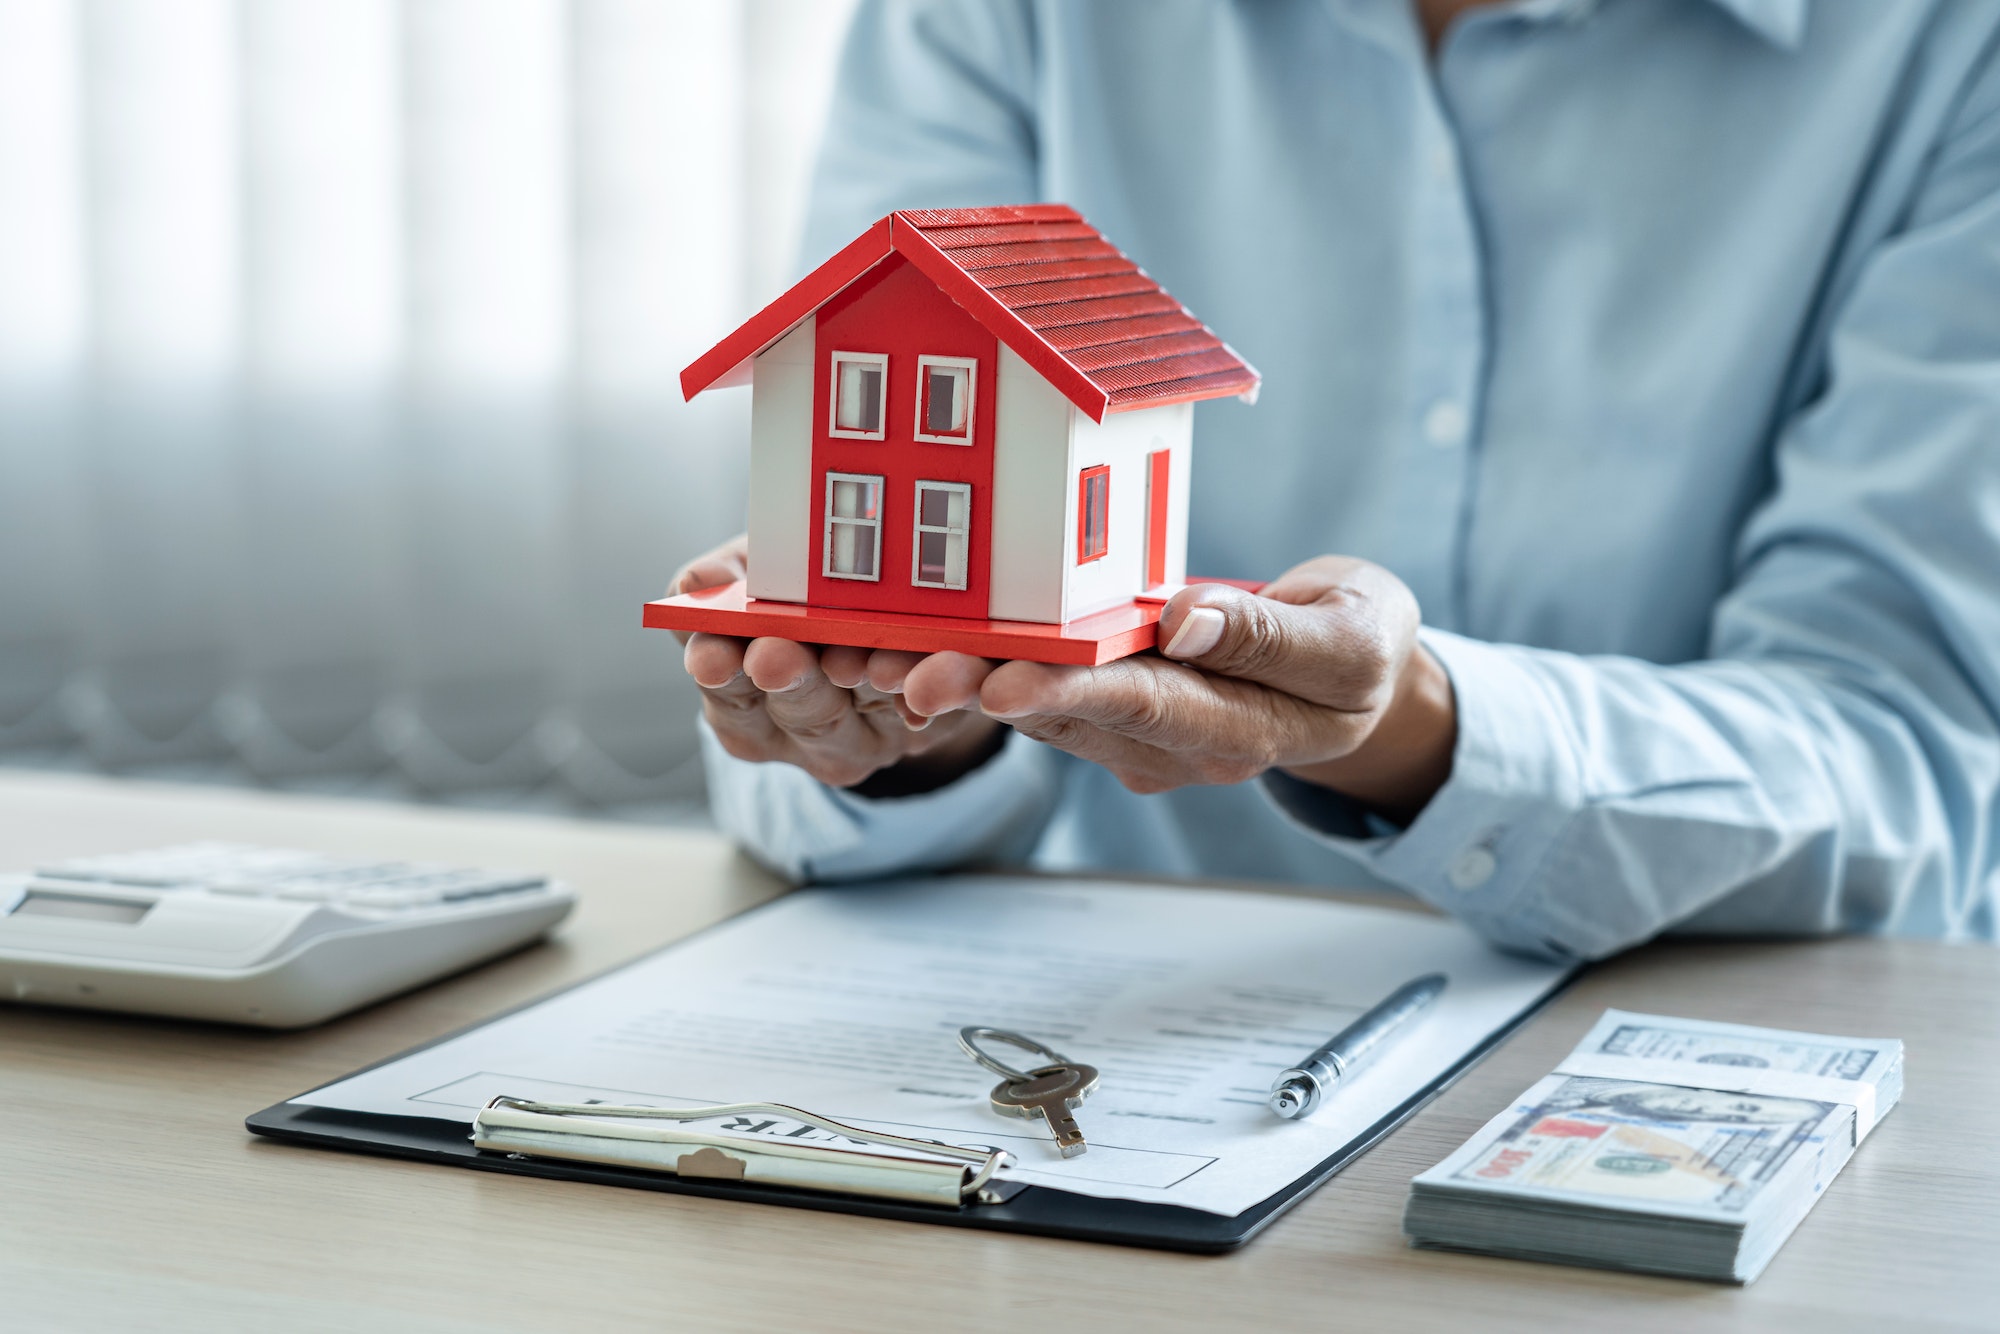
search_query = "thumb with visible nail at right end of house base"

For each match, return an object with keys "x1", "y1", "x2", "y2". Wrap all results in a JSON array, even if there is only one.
[{"x1": 1160, "y1": 580, "x2": 1416, "y2": 712}]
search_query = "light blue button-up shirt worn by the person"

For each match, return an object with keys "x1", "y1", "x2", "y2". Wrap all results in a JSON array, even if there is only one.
[{"x1": 708, "y1": 0, "x2": 2000, "y2": 956}]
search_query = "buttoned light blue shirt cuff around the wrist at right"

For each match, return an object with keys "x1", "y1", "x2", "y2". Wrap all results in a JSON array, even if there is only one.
[{"x1": 1260, "y1": 628, "x2": 1584, "y2": 958}]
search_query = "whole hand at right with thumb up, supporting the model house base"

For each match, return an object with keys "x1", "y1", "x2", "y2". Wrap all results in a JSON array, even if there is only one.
[{"x1": 980, "y1": 556, "x2": 1458, "y2": 820}]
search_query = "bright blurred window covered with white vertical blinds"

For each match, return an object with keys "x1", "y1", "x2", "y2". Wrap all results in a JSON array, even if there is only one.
[{"x1": 0, "y1": 0, "x2": 850, "y2": 818}]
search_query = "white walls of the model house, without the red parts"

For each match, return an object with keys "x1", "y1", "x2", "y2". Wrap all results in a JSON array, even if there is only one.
[{"x1": 748, "y1": 318, "x2": 1194, "y2": 624}]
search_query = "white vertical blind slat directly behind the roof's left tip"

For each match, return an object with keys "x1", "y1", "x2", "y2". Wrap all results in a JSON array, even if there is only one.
[{"x1": 542, "y1": 0, "x2": 752, "y2": 796}]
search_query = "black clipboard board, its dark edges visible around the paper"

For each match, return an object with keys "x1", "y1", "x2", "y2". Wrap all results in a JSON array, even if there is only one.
[{"x1": 244, "y1": 904, "x2": 1576, "y2": 1254}]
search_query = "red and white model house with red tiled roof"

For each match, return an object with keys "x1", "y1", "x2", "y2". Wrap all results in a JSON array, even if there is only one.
[{"x1": 648, "y1": 204, "x2": 1258, "y2": 656}]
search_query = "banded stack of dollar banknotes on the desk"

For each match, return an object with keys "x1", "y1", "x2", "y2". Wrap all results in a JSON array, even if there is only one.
[{"x1": 1402, "y1": 1010, "x2": 1902, "y2": 1282}]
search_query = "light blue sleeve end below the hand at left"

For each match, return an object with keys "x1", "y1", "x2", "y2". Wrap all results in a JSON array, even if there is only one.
[{"x1": 700, "y1": 720, "x2": 1060, "y2": 880}]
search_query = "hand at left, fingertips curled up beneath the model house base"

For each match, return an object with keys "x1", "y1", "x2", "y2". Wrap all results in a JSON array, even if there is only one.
[{"x1": 668, "y1": 536, "x2": 1002, "y2": 796}]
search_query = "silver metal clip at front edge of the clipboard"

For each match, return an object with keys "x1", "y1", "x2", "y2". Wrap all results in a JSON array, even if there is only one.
[{"x1": 472, "y1": 1096, "x2": 1014, "y2": 1208}]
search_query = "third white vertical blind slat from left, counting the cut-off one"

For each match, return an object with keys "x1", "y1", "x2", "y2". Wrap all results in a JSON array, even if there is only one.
[{"x1": 234, "y1": 0, "x2": 406, "y2": 778}]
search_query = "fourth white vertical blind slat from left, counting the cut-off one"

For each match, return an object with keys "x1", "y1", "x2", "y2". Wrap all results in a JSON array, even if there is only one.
[{"x1": 388, "y1": 0, "x2": 572, "y2": 788}]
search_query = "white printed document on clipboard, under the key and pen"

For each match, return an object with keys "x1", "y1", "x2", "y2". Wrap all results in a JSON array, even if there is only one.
[{"x1": 294, "y1": 876, "x2": 1566, "y2": 1214}]
